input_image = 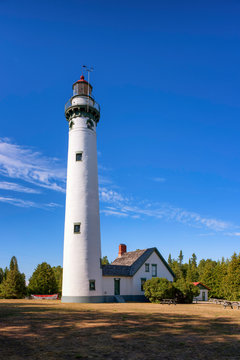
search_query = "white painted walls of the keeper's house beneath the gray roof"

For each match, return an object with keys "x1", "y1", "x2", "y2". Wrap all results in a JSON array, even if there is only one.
[{"x1": 103, "y1": 252, "x2": 173, "y2": 295}]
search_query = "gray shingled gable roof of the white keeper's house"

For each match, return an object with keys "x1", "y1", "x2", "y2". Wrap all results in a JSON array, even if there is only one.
[{"x1": 102, "y1": 248, "x2": 175, "y2": 277}]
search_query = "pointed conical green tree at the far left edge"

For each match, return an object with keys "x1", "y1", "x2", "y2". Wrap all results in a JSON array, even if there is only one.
[{"x1": 0, "y1": 256, "x2": 26, "y2": 299}]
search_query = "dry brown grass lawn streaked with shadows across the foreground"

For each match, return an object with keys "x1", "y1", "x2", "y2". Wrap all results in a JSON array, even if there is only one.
[{"x1": 0, "y1": 302, "x2": 240, "y2": 360}]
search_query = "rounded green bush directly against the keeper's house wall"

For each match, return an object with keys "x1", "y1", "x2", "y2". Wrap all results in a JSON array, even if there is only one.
[{"x1": 143, "y1": 278, "x2": 174, "y2": 303}]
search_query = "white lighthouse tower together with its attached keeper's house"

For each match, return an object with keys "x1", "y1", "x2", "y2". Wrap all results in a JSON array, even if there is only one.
[{"x1": 62, "y1": 75, "x2": 174, "y2": 303}]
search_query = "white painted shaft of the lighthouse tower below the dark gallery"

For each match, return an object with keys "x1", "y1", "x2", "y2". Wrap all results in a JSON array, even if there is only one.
[{"x1": 63, "y1": 97, "x2": 103, "y2": 296}]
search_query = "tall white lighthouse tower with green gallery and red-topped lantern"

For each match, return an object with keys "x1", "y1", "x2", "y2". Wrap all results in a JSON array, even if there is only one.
[{"x1": 62, "y1": 75, "x2": 104, "y2": 302}]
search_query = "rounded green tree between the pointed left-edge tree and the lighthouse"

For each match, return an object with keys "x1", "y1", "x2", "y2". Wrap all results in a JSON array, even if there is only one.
[{"x1": 28, "y1": 262, "x2": 58, "y2": 295}]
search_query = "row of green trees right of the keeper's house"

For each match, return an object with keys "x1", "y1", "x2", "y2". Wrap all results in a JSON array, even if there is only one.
[{"x1": 168, "y1": 250, "x2": 240, "y2": 301}]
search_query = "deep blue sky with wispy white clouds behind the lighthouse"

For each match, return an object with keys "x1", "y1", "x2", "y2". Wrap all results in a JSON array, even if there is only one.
[{"x1": 0, "y1": 0, "x2": 240, "y2": 277}]
